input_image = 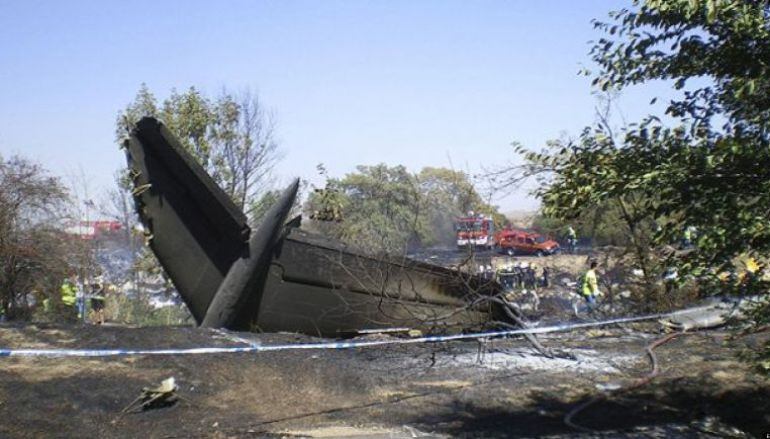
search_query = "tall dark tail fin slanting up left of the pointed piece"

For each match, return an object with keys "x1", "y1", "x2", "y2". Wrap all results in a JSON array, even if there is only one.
[{"x1": 125, "y1": 117, "x2": 250, "y2": 323}]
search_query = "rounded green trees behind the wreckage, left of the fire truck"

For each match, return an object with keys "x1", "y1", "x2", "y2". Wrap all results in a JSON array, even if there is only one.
[{"x1": 308, "y1": 164, "x2": 502, "y2": 253}]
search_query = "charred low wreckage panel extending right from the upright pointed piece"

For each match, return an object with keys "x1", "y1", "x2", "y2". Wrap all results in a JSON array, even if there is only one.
[{"x1": 258, "y1": 229, "x2": 496, "y2": 334}]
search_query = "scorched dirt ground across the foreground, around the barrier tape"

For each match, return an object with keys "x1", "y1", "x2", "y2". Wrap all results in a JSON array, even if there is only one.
[{"x1": 0, "y1": 324, "x2": 770, "y2": 438}]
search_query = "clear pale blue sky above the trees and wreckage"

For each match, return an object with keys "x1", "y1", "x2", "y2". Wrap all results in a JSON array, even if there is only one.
[{"x1": 0, "y1": 0, "x2": 666, "y2": 210}]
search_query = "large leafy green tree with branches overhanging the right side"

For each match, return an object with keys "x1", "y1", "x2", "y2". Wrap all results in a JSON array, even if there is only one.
[{"x1": 504, "y1": 0, "x2": 770, "y2": 364}]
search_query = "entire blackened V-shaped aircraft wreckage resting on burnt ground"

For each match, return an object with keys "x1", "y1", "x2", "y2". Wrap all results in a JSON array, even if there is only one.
[{"x1": 125, "y1": 118, "x2": 498, "y2": 336}]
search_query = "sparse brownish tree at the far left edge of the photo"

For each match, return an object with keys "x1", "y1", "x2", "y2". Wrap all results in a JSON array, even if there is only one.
[{"x1": 0, "y1": 156, "x2": 75, "y2": 317}]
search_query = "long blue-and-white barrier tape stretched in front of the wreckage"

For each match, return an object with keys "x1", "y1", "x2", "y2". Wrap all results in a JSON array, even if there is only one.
[{"x1": 0, "y1": 313, "x2": 664, "y2": 357}]
